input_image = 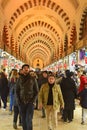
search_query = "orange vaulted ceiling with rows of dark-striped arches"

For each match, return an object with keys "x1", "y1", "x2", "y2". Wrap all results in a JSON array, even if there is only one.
[{"x1": 0, "y1": 0, "x2": 87, "y2": 68}]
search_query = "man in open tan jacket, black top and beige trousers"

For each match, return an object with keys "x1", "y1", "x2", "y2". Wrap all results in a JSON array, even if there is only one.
[{"x1": 38, "y1": 74, "x2": 64, "y2": 130}]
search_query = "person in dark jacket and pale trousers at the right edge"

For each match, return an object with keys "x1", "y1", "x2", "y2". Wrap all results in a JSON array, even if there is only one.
[{"x1": 78, "y1": 81, "x2": 87, "y2": 125}]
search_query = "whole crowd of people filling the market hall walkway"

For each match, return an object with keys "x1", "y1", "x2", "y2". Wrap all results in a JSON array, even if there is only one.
[{"x1": 0, "y1": 64, "x2": 87, "y2": 130}]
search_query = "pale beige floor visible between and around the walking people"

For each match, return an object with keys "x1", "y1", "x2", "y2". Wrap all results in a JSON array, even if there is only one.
[{"x1": 0, "y1": 101, "x2": 87, "y2": 130}]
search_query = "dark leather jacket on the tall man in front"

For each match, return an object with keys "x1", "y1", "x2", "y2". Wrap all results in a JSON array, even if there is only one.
[{"x1": 16, "y1": 74, "x2": 38, "y2": 104}]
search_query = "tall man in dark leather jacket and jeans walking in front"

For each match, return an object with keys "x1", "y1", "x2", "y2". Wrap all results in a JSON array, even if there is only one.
[{"x1": 16, "y1": 64, "x2": 38, "y2": 130}]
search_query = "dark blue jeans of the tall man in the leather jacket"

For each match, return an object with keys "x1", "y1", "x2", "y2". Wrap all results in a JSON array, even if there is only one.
[{"x1": 19, "y1": 103, "x2": 34, "y2": 130}]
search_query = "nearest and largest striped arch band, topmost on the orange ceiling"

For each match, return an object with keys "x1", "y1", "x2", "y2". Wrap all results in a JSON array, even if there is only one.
[{"x1": 9, "y1": 0, "x2": 70, "y2": 29}]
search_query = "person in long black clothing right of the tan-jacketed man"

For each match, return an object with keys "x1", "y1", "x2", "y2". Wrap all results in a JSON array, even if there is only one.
[{"x1": 60, "y1": 70, "x2": 77, "y2": 122}]
